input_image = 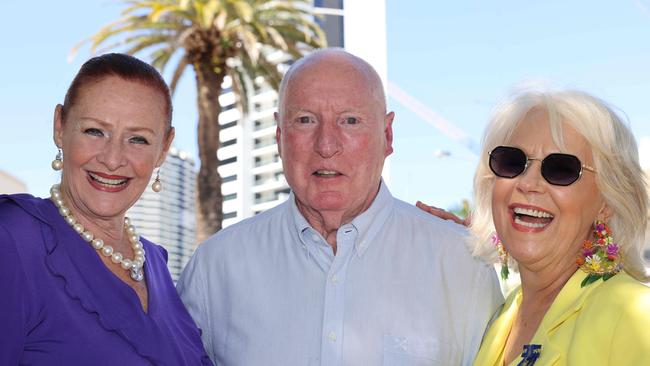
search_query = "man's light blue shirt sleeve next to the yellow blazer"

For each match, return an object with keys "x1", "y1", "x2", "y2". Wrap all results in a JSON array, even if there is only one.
[{"x1": 462, "y1": 265, "x2": 503, "y2": 365}]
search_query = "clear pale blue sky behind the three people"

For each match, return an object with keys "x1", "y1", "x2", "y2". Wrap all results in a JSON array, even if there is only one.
[{"x1": 0, "y1": 0, "x2": 650, "y2": 212}]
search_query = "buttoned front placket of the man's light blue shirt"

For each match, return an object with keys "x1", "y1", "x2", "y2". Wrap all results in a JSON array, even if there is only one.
[{"x1": 321, "y1": 225, "x2": 357, "y2": 366}]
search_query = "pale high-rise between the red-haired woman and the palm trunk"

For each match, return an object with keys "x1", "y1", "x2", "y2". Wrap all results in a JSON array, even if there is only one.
[{"x1": 127, "y1": 147, "x2": 196, "y2": 282}]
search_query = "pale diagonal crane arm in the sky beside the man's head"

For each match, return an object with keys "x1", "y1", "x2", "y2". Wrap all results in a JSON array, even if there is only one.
[{"x1": 388, "y1": 81, "x2": 480, "y2": 155}]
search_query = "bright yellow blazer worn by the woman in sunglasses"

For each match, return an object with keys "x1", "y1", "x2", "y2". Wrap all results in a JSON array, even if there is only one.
[{"x1": 474, "y1": 270, "x2": 650, "y2": 366}]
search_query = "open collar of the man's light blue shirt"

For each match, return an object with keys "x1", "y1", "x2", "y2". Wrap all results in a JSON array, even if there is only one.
[{"x1": 289, "y1": 179, "x2": 393, "y2": 256}]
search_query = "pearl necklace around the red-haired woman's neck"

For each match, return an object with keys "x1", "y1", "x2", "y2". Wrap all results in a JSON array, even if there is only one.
[{"x1": 50, "y1": 184, "x2": 145, "y2": 282}]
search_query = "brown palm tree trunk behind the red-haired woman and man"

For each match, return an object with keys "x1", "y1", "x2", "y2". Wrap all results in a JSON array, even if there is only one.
[{"x1": 193, "y1": 57, "x2": 225, "y2": 243}]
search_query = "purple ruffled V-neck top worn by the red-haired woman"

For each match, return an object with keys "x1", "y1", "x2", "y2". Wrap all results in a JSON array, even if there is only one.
[{"x1": 0, "y1": 195, "x2": 212, "y2": 365}]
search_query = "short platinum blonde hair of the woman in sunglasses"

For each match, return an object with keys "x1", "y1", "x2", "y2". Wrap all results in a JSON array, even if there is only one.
[{"x1": 470, "y1": 90, "x2": 649, "y2": 281}]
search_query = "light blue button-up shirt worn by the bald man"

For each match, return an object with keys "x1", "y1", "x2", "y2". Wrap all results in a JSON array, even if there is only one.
[{"x1": 178, "y1": 183, "x2": 503, "y2": 366}]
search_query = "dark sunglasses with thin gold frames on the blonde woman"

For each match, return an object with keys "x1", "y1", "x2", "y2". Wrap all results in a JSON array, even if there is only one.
[{"x1": 490, "y1": 146, "x2": 596, "y2": 186}]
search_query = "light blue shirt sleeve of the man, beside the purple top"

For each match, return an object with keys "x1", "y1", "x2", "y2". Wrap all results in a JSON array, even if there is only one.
[{"x1": 176, "y1": 250, "x2": 217, "y2": 365}]
